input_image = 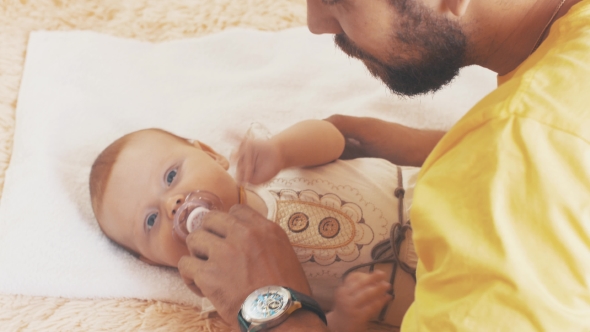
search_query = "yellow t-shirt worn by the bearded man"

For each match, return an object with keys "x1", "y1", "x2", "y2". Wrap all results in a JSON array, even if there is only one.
[{"x1": 402, "y1": 0, "x2": 590, "y2": 332}]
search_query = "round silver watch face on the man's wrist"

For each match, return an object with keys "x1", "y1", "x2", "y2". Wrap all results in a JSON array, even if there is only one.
[{"x1": 242, "y1": 286, "x2": 291, "y2": 323}]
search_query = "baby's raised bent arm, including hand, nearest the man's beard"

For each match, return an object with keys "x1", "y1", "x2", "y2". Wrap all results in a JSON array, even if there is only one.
[{"x1": 236, "y1": 120, "x2": 344, "y2": 184}]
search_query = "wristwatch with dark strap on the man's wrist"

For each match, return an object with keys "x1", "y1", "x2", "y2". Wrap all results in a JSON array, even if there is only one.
[{"x1": 238, "y1": 286, "x2": 327, "y2": 332}]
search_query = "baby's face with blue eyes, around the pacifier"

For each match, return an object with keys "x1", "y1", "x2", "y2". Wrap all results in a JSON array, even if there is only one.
[{"x1": 97, "y1": 130, "x2": 239, "y2": 267}]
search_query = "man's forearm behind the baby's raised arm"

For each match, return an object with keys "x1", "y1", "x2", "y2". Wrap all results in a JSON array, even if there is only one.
[{"x1": 326, "y1": 115, "x2": 445, "y2": 166}]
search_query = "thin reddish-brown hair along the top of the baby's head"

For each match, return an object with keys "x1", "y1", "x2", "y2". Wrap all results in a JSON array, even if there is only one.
[{"x1": 89, "y1": 128, "x2": 189, "y2": 256}]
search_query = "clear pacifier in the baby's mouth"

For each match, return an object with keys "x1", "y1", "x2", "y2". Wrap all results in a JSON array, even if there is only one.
[{"x1": 173, "y1": 190, "x2": 222, "y2": 242}]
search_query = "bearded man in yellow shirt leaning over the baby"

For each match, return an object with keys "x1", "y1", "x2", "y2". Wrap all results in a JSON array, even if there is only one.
[{"x1": 179, "y1": 0, "x2": 590, "y2": 331}]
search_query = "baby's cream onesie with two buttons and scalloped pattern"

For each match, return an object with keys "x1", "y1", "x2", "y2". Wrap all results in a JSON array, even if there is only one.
[{"x1": 248, "y1": 158, "x2": 419, "y2": 326}]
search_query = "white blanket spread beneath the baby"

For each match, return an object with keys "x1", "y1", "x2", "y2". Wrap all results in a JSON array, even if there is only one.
[{"x1": 0, "y1": 28, "x2": 495, "y2": 305}]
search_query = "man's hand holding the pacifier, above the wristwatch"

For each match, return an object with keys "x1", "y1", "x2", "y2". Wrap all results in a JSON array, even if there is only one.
[{"x1": 178, "y1": 205, "x2": 311, "y2": 330}]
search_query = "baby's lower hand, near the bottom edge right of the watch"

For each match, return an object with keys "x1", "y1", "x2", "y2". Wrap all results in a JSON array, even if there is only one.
[{"x1": 327, "y1": 271, "x2": 392, "y2": 332}]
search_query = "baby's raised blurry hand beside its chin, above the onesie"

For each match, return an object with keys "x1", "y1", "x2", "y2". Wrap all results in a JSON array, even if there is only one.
[{"x1": 232, "y1": 135, "x2": 283, "y2": 184}]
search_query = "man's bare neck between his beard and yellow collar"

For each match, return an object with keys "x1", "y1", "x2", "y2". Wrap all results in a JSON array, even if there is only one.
[{"x1": 466, "y1": 0, "x2": 581, "y2": 75}]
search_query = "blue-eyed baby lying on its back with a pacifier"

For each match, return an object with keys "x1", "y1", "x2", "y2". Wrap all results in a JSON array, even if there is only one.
[{"x1": 90, "y1": 120, "x2": 418, "y2": 331}]
